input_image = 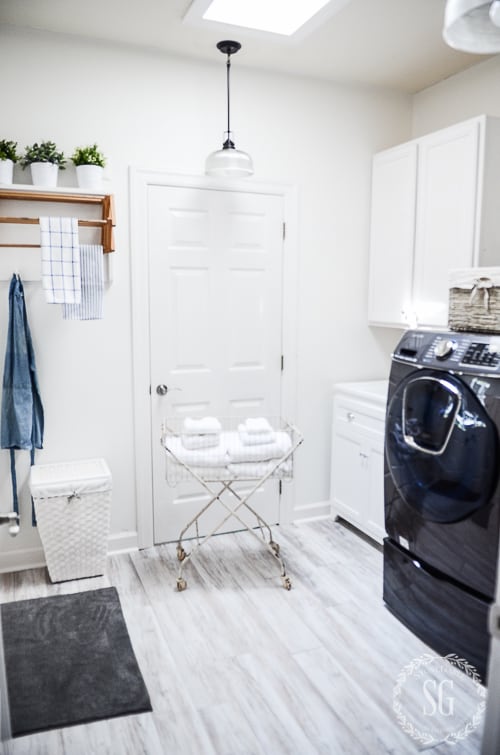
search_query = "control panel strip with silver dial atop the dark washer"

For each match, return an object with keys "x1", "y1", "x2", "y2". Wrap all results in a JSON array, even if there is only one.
[{"x1": 393, "y1": 330, "x2": 500, "y2": 375}]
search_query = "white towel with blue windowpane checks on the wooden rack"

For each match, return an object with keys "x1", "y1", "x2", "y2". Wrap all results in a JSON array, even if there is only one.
[{"x1": 40, "y1": 218, "x2": 81, "y2": 304}]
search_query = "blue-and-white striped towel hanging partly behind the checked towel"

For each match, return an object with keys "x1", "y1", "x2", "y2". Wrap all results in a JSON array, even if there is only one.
[{"x1": 63, "y1": 244, "x2": 104, "y2": 320}]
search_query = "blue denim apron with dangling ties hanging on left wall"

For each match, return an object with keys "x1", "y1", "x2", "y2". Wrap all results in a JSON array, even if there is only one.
[{"x1": 0, "y1": 275, "x2": 43, "y2": 525}]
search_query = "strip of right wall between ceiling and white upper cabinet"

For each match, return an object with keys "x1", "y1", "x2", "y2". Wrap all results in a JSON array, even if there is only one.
[{"x1": 412, "y1": 55, "x2": 500, "y2": 137}]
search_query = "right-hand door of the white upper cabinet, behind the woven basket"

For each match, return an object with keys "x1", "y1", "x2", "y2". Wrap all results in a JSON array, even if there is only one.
[{"x1": 413, "y1": 120, "x2": 480, "y2": 326}]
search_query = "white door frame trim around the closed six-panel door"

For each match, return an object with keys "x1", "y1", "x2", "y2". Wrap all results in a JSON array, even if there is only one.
[{"x1": 129, "y1": 168, "x2": 299, "y2": 548}]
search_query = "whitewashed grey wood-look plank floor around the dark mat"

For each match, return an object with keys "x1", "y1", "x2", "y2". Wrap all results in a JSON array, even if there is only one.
[{"x1": 0, "y1": 520, "x2": 480, "y2": 755}]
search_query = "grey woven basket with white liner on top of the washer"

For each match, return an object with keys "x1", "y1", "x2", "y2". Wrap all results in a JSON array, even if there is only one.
[{"x1": 448, "y1": 267, "x2": 500, "y2": 333}]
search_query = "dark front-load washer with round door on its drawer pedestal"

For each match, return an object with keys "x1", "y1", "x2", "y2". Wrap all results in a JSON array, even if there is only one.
[{"x1": 384, "y1": 330, "x2": 500, "y2": 680}]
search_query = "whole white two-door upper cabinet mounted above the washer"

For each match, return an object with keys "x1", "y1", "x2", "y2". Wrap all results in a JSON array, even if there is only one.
[{"x1": 369, "y1": 116, "x2": 500, "y2": 327}]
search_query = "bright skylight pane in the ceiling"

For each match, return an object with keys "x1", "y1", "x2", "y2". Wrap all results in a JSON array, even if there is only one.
[{"x1": 199, "y1": 0, "x2": 330, "y2": 36}]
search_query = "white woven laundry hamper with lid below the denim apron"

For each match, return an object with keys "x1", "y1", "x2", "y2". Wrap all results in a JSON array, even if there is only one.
[{"x1": 30, "y1": 459, "x2": 111, "y2": 582}]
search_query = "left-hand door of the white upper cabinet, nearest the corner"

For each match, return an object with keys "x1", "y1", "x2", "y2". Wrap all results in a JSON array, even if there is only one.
[{"x1": 368, "y1": 142, "x2": 417, "y2": 325}]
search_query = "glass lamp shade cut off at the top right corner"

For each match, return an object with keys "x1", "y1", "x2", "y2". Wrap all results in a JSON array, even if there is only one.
[{"x1": 443, "y1": 0, "x2": 500, "y2": 55}]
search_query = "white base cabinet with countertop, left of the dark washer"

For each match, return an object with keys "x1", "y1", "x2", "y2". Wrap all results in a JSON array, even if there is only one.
[{"x1": 330, "y1": 380, "x2": 388, "y2": 543}]
